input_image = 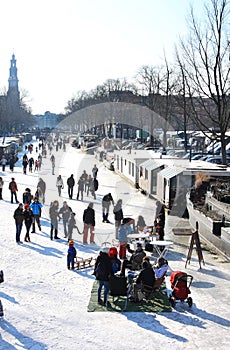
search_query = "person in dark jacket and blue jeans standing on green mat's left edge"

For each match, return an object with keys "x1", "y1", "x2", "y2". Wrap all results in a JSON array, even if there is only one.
[{"x1": 93, "y1": 247, "x2": 114, "y2": 306}]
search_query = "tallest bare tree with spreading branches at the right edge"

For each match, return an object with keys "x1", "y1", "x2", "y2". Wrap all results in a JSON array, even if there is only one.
[{"x1": 180, "y1": 0, "x2": 230, "y2": 164}]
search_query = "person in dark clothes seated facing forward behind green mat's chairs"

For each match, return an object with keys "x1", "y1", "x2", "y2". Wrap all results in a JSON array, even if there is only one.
[{"x1": 121, "y1": 242, "x2": 146, "y2": 275}]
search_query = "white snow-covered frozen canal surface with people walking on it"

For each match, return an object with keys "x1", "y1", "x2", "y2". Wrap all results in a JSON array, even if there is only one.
[{"x1": 0, "y1": 141, "x2": 230, "y2": 350}]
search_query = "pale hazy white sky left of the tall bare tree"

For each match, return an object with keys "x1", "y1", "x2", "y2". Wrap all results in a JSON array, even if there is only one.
[{"x1": 0, "y1": 0, "x2": 205, "y2": 114}]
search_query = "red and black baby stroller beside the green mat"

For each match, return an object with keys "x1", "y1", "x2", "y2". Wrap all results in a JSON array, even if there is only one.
[{"x1": 169, "y1": 271, "x2": 193, "y2": 307}]
